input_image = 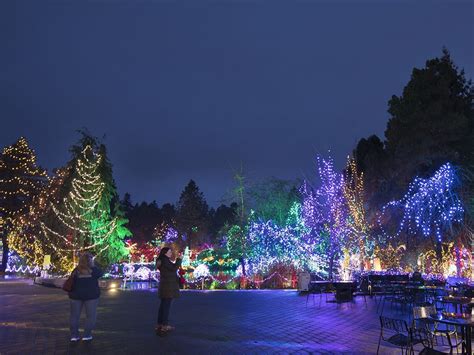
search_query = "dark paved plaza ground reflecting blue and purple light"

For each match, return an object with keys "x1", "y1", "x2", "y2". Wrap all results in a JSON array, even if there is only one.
[{"x1": 0, "y1": 279, "x2": 412, "y2": 355}]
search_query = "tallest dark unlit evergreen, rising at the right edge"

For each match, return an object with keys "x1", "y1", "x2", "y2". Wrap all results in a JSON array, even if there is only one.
[{"x1": 385, "y1": 49, "x2": 474, "y2": 191}]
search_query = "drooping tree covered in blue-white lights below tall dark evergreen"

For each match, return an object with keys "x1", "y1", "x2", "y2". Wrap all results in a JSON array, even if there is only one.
[{"x1": 379, "y1": 163, "x2": 464, "y2": 243}]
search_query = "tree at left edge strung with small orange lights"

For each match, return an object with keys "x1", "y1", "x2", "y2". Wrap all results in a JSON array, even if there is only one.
[{"x1": 0, "y1": 137, "x2": 48, "y2": 271}]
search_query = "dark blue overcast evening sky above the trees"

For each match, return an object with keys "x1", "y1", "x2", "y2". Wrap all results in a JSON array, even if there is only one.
[{"x1": 0, "y1": 0, "x2": 474, "y2": 205}]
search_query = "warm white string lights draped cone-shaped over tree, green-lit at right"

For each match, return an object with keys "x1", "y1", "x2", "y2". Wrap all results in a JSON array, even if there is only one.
[{"x1": 14, "y1": 145, "x2": 131, "y2": 271}]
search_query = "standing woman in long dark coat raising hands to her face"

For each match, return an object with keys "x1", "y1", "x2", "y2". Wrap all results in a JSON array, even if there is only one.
[{"x1": 155, "y1": 247, "x2": 181, "y2": 336}]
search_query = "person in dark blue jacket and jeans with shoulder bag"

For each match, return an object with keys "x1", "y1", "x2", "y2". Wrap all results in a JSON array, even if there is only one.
[{"x1": 69, "y1": 253, "x2": 103, "y2": 342}]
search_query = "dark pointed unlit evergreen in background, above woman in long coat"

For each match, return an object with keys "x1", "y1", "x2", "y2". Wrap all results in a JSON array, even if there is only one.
[{"x1": 176, "y1": 180, "x2": 209, "y2": 248}]
